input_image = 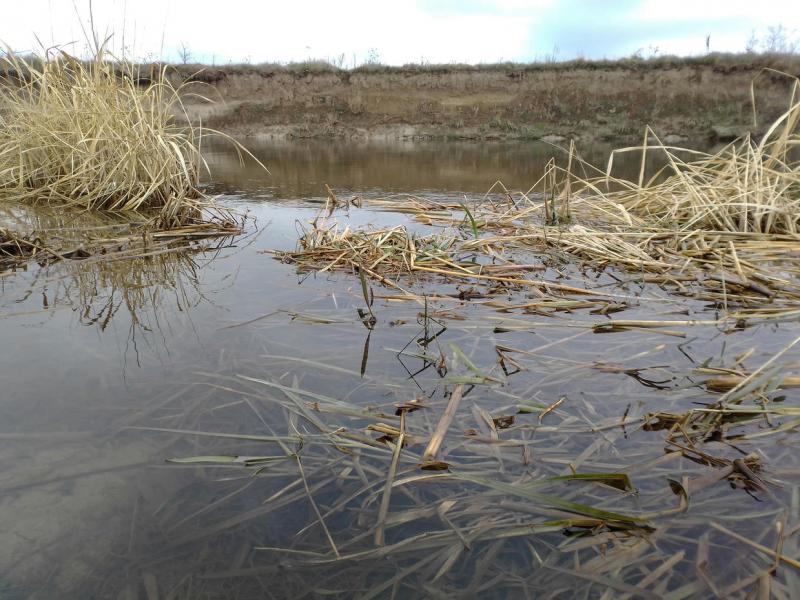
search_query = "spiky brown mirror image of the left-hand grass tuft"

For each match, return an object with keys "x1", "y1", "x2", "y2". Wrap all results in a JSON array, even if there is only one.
[{"x1": 0, "y1": 207, "x2": 238, "y2": 336}]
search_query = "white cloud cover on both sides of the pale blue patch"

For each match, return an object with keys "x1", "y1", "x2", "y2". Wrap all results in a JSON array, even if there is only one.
[{"x1": 0, "y1": 0, "x2": 800, "y2": 66}]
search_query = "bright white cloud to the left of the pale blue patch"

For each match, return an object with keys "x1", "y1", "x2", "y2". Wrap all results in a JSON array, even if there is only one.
[{"x1": 0, "y1": 0, "x2": 542, "y2": 64}]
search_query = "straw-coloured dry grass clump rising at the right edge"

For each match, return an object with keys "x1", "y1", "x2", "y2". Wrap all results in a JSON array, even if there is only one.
[{"x1": 531, "y1": 72, "x2": 800, "y2": 236}]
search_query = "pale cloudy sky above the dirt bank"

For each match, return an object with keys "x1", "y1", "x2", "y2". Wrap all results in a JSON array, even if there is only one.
[{"x1": 0, "y1": 0, "x2": 800, "y2": 67}]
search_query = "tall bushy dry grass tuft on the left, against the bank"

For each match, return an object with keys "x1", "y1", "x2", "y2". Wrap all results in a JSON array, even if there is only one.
[{"x1": 0, "y1": 47, "x2": 222, "y2": 227}]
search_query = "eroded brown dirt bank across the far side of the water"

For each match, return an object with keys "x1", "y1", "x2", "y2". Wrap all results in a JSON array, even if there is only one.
[{"x1": 173, "y1": 55, "x2": 800, "y2": 142}]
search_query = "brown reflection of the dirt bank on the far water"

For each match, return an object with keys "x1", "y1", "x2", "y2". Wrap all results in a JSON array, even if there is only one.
[{"x1": 200, "y1": 139, "x2": 680, "y2": 200}]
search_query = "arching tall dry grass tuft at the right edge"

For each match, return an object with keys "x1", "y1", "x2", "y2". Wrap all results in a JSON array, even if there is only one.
[{"x1": 584, "y1": 75, "x2": 800, "y2": 235}]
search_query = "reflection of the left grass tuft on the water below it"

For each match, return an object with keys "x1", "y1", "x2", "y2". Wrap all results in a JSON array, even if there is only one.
[{"x1": 0, "y1": 207, "x2": 246, "y2": 362}]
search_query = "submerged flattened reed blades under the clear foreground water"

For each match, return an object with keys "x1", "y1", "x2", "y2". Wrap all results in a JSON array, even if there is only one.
[{"x1": 111, "y1": 328, "x2": 798, "y2": 598}]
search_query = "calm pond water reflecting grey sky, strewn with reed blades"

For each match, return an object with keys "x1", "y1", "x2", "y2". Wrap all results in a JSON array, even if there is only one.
[{"x1": 0, "y1": 141, "x2": 800, "y2": 599}]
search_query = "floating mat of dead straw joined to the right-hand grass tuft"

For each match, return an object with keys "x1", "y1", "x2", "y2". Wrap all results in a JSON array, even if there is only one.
[{"x1": 281, "y1": 82, "x2": 800, "y2": 324}]
